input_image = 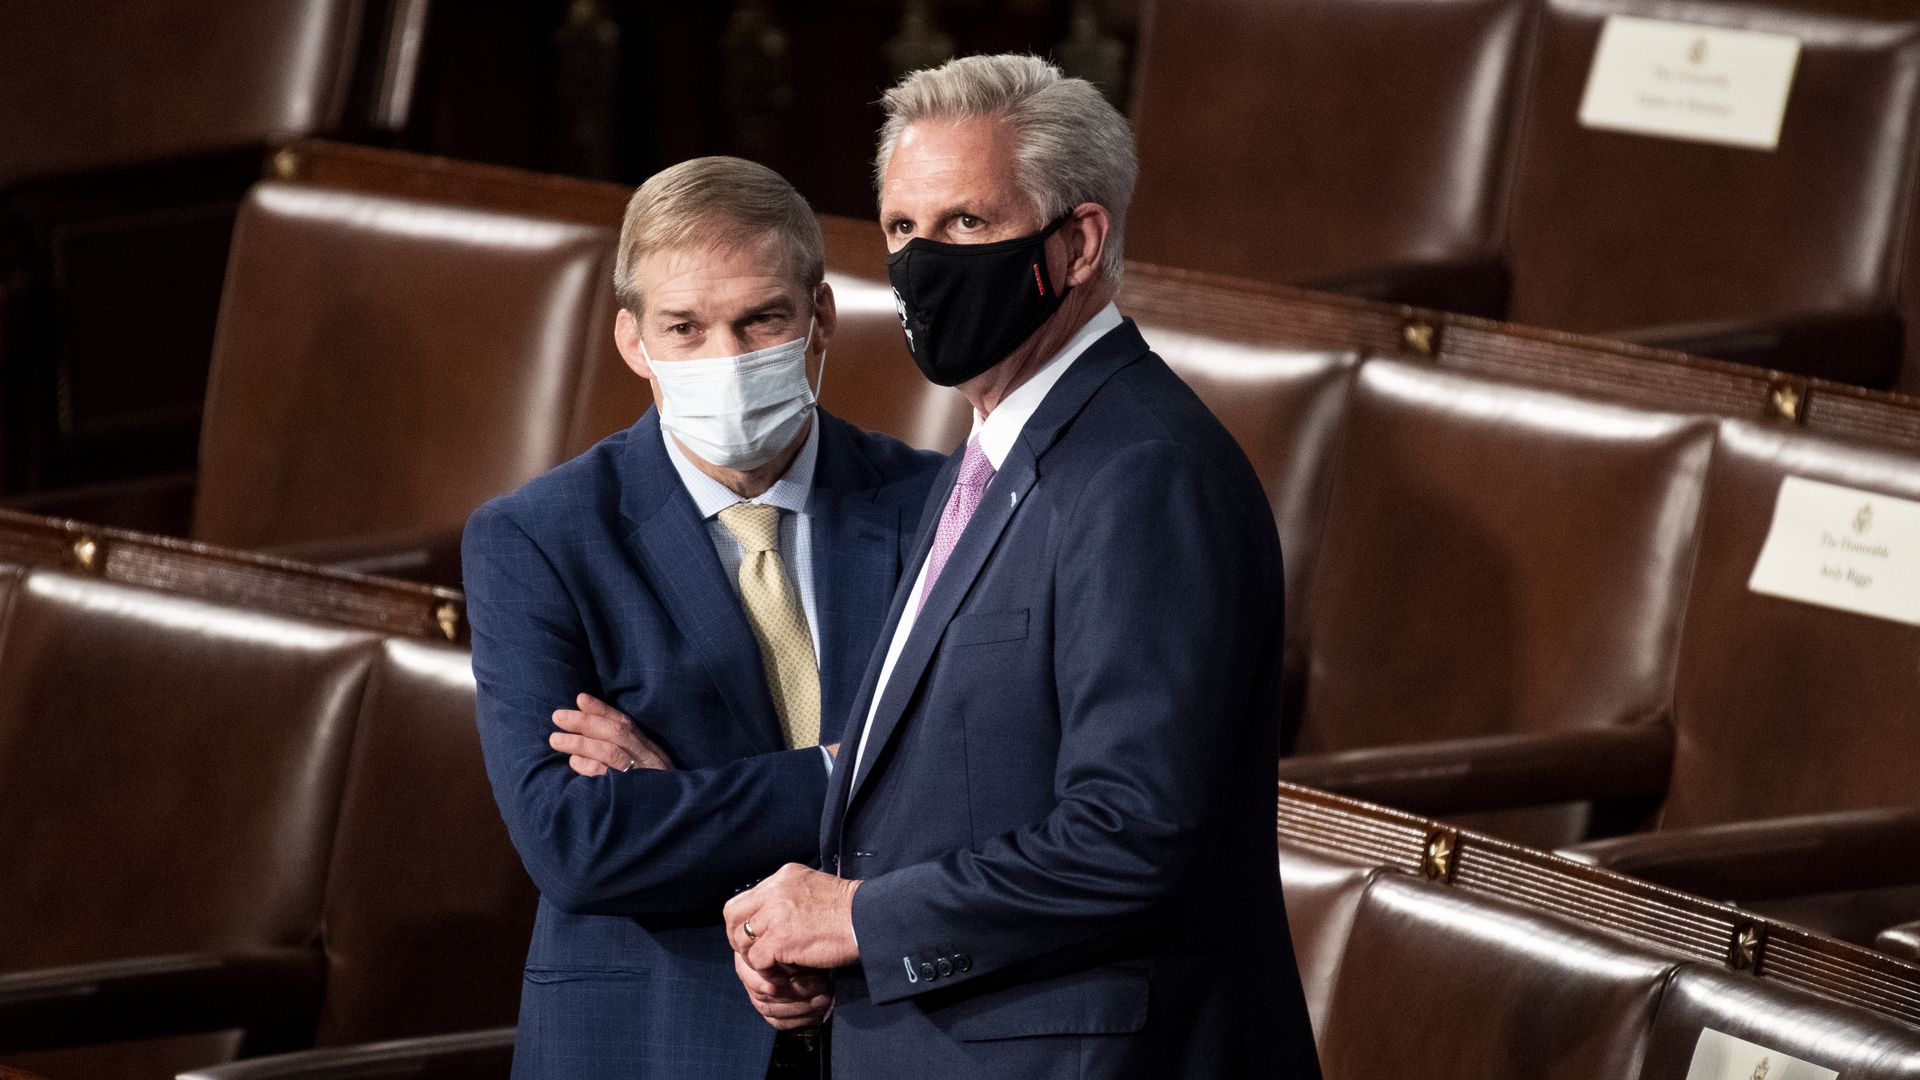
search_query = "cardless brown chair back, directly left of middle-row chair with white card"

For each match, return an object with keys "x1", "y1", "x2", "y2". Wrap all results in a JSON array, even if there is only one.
[{"x1": 1281, "y1": 359, "x2": 1713, "y2": 844}]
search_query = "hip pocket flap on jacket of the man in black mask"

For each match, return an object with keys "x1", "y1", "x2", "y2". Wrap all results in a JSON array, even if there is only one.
[{"x1": 935, "y1": 967, "x2": 1148, "y2": 1042}]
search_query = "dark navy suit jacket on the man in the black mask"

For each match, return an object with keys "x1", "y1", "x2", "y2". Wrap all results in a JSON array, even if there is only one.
[{"x1": 822, "y1": 321, "x2": 1319, "y2": 1080}]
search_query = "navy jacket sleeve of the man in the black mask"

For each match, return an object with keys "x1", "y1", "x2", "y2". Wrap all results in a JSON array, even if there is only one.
[{"x1": 852, "y1": 434, "x2": 1283, "y2": 1003}]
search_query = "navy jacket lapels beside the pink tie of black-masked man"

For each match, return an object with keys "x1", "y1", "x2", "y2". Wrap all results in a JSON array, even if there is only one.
[{"x1": 845, "y1": 319, "x2": 1146, "y2": 813}]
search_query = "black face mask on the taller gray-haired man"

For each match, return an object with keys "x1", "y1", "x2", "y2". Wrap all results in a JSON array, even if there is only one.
[{"x1": 887, "y1": 213, "x2": 1071, "y2": 386}]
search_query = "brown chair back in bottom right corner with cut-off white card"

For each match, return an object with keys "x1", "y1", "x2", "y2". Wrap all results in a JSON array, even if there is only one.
[{"x1": 1640, "y1": 965, "x2": 1920, "y2": 1080}]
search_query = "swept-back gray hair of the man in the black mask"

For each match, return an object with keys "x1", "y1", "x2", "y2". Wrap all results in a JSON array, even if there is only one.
[{"x1": 874, "y1": 54, "x2": 1140, "y2": 282}]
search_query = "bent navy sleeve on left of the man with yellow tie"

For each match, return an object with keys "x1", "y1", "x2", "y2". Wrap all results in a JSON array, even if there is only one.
[{"x1": 463, "y1": 505, "x2": 826, "y2": 915}]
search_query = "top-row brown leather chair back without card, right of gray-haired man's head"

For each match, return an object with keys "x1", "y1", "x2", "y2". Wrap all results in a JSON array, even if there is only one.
[{"x1": 1127, "y1": 0, "x2": 1532, "y2": 315}]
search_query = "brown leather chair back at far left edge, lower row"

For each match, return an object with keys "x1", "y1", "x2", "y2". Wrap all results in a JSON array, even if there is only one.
[{"x1": 0, "y1": 571, "x2": 378, "y2": 970}]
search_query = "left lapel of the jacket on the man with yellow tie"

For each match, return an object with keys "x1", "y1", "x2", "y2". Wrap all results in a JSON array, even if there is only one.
[{"x1": 620, "y1": 411, "x2": 787, "y2": 751}]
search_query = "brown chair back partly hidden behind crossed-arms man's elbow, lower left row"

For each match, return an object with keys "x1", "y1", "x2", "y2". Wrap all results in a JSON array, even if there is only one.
[{"x1": 315, "y1": 638, "x2": 536, "y2": 1045}]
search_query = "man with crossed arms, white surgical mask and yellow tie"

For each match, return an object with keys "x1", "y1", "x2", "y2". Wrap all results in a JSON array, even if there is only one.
[{"x1": 463, "y1": 158, "x2": 939, "y2": 1080}]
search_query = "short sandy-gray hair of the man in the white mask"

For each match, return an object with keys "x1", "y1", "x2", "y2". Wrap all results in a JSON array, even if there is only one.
[{"x1": 612, "y1": 158, "x2": 826, "y2": 315}]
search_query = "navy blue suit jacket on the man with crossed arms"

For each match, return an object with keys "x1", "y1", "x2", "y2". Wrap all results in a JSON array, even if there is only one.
[{"x1": 463, "y1": 411, "x2": 939, "y2": 1080}]
